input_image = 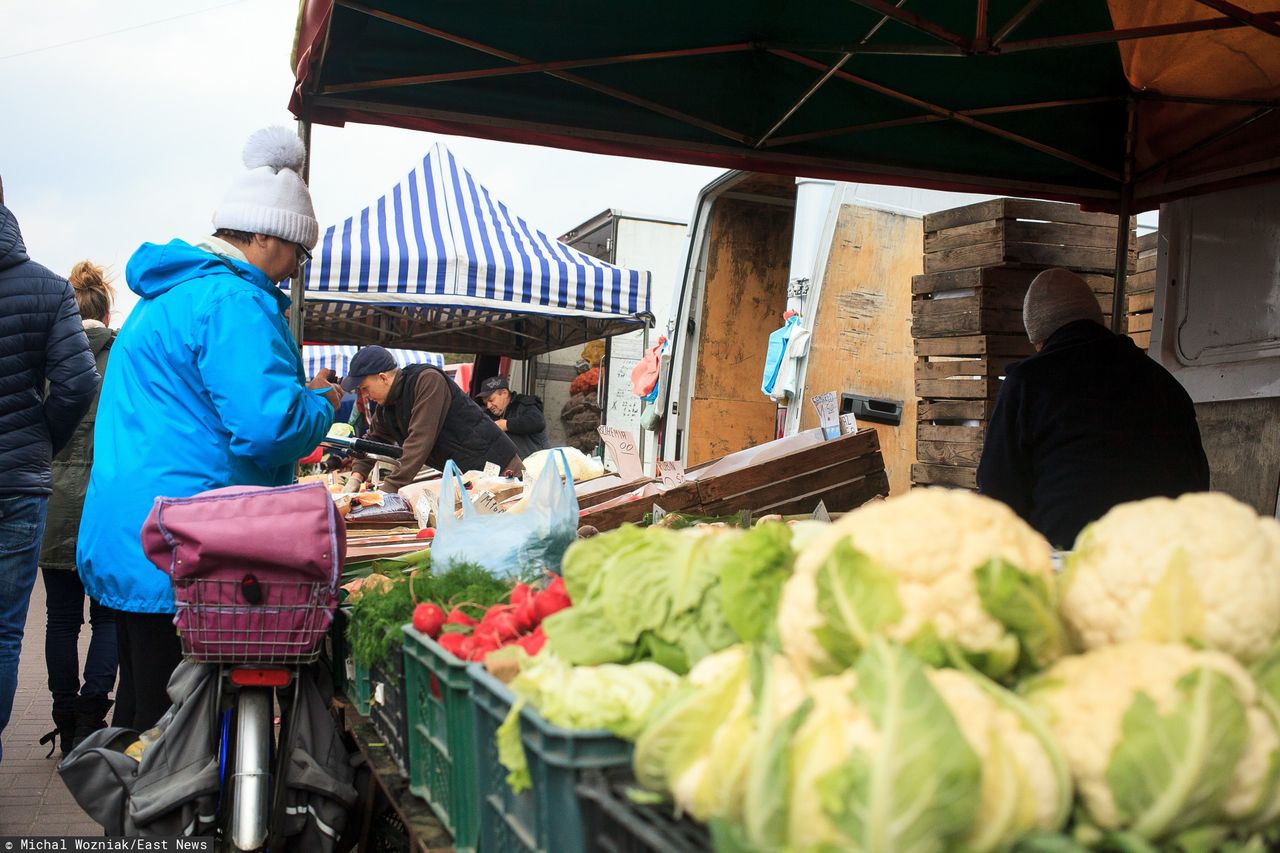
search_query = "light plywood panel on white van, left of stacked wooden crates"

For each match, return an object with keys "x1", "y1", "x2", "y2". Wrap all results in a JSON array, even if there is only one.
[{"x1": 798, "y1": 205, "x2": 924, "y2": 494}]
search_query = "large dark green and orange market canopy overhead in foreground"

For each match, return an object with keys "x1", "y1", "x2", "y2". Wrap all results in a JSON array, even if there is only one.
[{"x1": 291, "y1": 0, "x2": 1280, "y2": 209}]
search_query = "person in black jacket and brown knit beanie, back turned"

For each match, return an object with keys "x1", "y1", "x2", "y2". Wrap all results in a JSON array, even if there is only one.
[{"x1": 978, "y1": 263, "x2": 1208, "y2": 548}]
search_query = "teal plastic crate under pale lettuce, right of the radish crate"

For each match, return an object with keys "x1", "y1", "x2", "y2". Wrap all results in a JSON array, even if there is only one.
[{"x1": 467, "y1": 663, "x2": 631, "y2": 853}]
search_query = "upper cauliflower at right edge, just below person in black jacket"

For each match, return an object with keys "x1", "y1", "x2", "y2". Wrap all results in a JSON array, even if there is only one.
[{"x1": 1062, "y1": 493, "x2": 1280, "y2": 662}]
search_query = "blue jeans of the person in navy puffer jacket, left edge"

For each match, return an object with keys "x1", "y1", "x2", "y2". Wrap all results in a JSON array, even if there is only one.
[{"x1": 0, "y1": 494, "x2": 49, "y2": 757}]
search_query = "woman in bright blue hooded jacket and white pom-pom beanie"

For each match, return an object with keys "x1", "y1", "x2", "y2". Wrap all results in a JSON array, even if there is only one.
[{"x1": 77, "y1": 128, "x2": 340, "y2": 731}]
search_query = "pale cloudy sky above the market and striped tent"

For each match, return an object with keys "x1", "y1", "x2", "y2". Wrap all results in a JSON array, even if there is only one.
[{"x1": 0, "y1": 0, "x2": 721, "y2": 324}]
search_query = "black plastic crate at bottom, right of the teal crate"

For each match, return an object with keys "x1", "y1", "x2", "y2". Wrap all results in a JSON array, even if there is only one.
[{"x1": 577, "y1": 767, "x2": 712, "y2": 853}]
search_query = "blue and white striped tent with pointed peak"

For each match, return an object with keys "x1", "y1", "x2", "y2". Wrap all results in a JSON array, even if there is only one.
[{"x1": 295, "y1": 145, "x2": 653, "y2": 359}]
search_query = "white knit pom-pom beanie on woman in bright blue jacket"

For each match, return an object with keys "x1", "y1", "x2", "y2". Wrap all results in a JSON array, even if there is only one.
[{"x1": 214, "y1": 127, "x2": 320, "y2": 248}]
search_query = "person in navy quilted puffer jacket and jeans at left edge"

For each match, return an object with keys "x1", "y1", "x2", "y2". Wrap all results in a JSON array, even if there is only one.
[{"x1": 0, "y1": 175, "x2": 99, "y2": 753}]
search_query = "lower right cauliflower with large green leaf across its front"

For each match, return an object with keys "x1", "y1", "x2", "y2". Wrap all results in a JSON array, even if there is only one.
[{"x1": 1024, "y1": 642, "x2": 1280, "y2": 841}]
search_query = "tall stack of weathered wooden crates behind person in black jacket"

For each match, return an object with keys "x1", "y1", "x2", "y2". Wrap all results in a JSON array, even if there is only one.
[{"x1": 911, "y1": 199, "x2": 1137, "y2": 489}]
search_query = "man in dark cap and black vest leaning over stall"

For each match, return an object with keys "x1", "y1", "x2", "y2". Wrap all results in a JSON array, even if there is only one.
[{"x1": 342, "y1": 347, "x2": 525, "y2": 492}]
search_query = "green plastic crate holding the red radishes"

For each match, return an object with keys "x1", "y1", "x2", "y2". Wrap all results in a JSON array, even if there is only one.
[{"x1": 404, "y1": 625, "x2": 480, "y2": 852}]
